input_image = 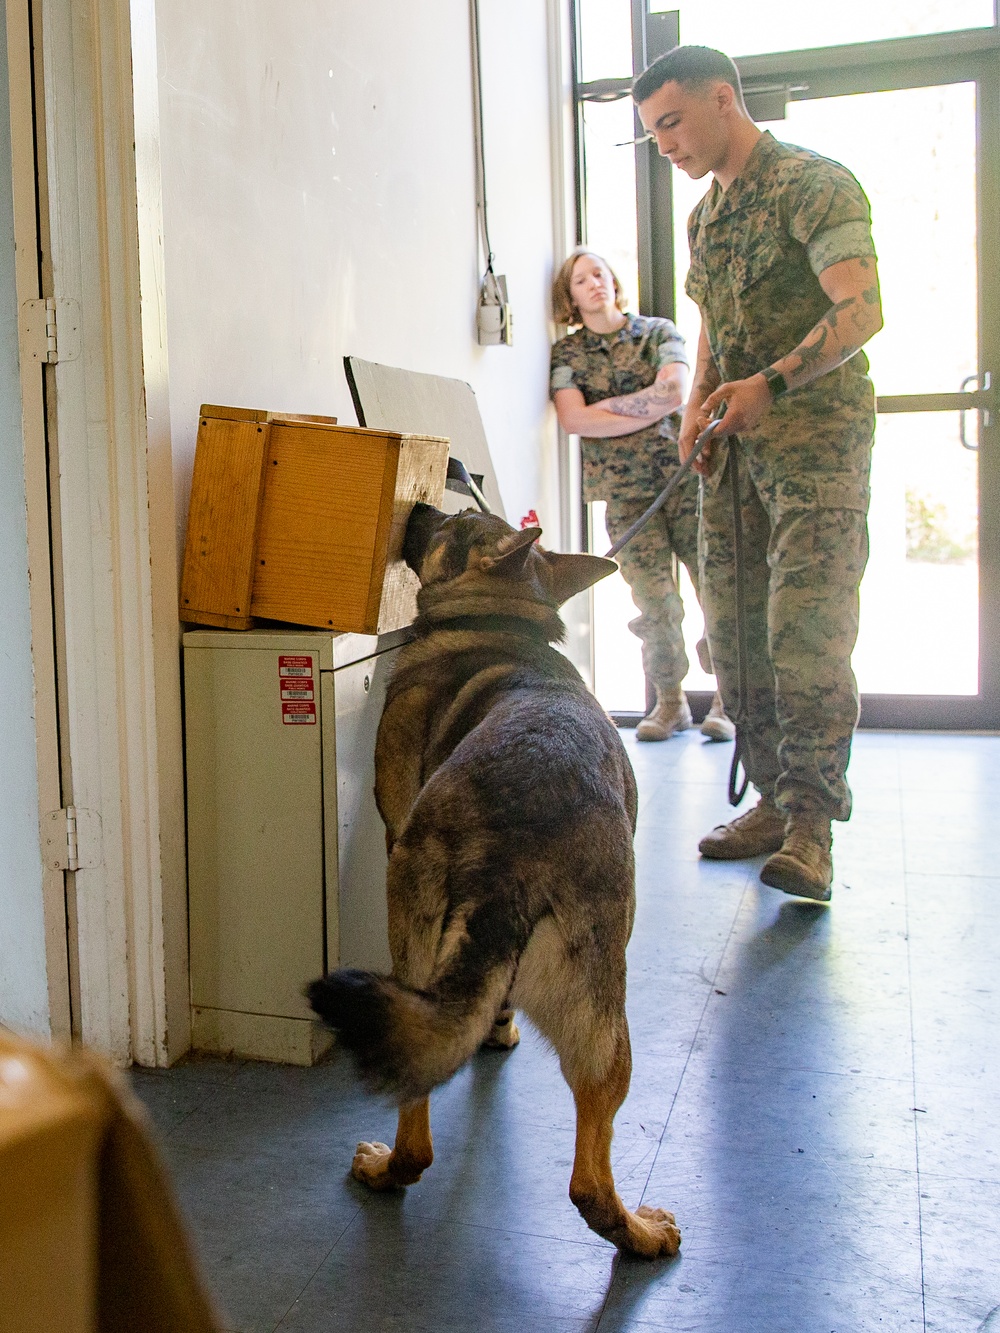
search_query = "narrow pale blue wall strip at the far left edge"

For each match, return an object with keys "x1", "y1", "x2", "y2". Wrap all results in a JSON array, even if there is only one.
[{"x1": 0, "y1": 5, "x2": 49, "y2": 1036}]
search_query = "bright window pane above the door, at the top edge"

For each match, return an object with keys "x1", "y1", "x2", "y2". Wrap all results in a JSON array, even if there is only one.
[{"x1": 650, "y1": 0, "x2": 993, "y2": 56}]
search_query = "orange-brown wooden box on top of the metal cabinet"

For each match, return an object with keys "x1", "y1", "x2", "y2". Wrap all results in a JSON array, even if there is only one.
[{"x1": 180, "y1": 405, "x2": 448, "y2": 635}]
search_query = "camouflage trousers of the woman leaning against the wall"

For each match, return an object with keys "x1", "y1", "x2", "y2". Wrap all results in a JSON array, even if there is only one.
[{"x1": 605, "y1": 473, "x2": 699, "y2": 690}]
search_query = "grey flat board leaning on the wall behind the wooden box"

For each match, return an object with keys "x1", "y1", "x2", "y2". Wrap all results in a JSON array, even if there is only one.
[{"x1": 344, "y1": 356, "x2": 507, "y2": 517}]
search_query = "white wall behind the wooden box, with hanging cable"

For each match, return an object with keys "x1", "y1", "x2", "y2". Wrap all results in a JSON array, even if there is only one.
[{"x1": 157, "y1": 0, "x2": 557, "y2": 537}]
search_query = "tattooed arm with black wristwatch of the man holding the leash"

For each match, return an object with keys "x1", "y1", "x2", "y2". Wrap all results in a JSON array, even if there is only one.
[{"x1": 703, "y1": 259, "x2": 881, "y2": 435}]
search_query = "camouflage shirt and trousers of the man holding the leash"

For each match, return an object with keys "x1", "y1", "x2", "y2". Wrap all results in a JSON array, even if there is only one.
[{"x1": 687, "y1": 133, "x2": 875, "y2": 820}]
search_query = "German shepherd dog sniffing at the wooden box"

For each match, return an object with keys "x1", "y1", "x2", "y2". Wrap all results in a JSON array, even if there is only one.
[{"x1": 307, "y1": 505, "x2": 680, "y2": 1258}]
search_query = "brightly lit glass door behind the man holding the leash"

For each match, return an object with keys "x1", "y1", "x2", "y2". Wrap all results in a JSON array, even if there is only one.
[{"x1": 570, "y1": 2, "x2": 1000, "y2": 726}]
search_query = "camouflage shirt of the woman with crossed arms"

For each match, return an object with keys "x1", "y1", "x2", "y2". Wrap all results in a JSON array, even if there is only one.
[{"x1": 549, "y1": 315, "x2": 688, "y2": 500}]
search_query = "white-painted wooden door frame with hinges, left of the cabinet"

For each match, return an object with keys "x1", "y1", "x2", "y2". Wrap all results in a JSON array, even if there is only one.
[{"x1": 36, "y1": 0, "x2": 191, "y2": 1065}]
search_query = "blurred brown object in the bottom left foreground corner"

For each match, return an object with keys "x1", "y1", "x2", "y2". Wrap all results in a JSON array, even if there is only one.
[{"x1": 0, "y1": 1028, "x2": 220, "y2": 1333}]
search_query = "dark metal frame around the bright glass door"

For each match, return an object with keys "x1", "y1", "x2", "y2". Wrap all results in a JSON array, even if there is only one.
[{"x1": 575, "y1": 12, "x2": 1000, "y2": 730}]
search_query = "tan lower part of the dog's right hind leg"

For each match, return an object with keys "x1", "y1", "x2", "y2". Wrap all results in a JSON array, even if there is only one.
[{"x1": 569, "y1": 1014, "x2": 680, "y2": 1258}]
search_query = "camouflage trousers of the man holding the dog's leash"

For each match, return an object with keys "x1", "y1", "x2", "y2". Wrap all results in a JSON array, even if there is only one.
[{"x1": 700, "y1": 423, "x2": 871, "y2": 820}]
